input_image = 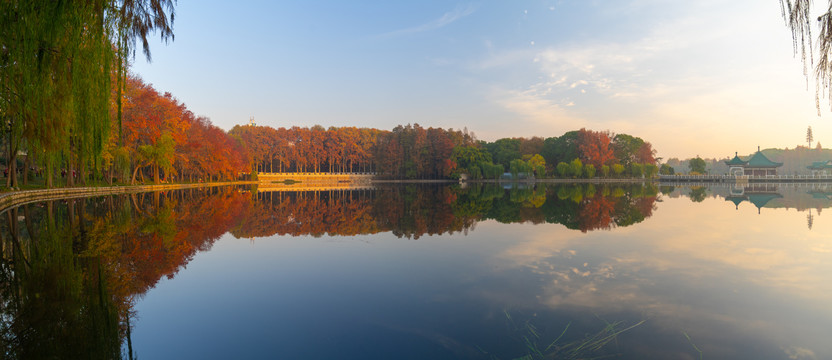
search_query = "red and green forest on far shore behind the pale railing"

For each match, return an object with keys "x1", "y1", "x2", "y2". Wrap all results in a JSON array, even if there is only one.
[{"x1": 229, "y1": 124, "x2": 658, "y2": 179}]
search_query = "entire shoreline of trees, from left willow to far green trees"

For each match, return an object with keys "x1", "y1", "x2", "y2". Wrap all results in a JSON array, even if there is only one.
[{"x1": 0, "y1": 0, "x2": 657, "y2": 189}]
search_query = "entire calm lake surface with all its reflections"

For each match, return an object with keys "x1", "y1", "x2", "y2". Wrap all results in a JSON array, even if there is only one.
[{"x1": 0, "y1": 184, "x2": 832, "y2": 359}]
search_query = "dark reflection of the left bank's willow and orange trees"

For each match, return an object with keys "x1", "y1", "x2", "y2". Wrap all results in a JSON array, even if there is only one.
[{"x1": 0, "y1": 190, "x2": 250, "y2": 359}]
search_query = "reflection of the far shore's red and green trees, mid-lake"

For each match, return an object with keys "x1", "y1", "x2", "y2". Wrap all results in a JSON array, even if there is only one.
[{"x1": 231, "y1": 184, "x2": 658, "y2": 239}]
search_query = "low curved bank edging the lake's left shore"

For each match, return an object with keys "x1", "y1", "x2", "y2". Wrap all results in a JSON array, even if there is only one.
[{"x1": 0, "y1": 181, "x2": 258, "y2": 213}]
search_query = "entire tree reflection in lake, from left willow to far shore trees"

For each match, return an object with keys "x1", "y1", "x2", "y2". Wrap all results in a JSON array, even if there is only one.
[{"x1": 0, "y1": 184, "x2": 658, "y2": 359}]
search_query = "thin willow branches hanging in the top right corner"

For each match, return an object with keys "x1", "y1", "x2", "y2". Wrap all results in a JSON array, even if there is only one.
[{"x1": 780, "y1": 0, "x2": 832, "y2": 111}]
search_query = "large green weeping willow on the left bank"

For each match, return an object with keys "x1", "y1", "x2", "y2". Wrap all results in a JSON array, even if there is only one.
[{"x1": 0, "y1": 0, "x2": 175, "y2": 187}]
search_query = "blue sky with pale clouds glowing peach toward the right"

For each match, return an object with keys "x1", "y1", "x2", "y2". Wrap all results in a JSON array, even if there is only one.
[{"x1": 133, "y1": 0, "x2": 832, "y2": 158}]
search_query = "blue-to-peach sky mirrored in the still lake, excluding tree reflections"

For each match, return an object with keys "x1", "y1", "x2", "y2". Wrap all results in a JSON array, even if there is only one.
[{"x1": 127, "y1": 184, "x2": 832, "y2": 359}]
